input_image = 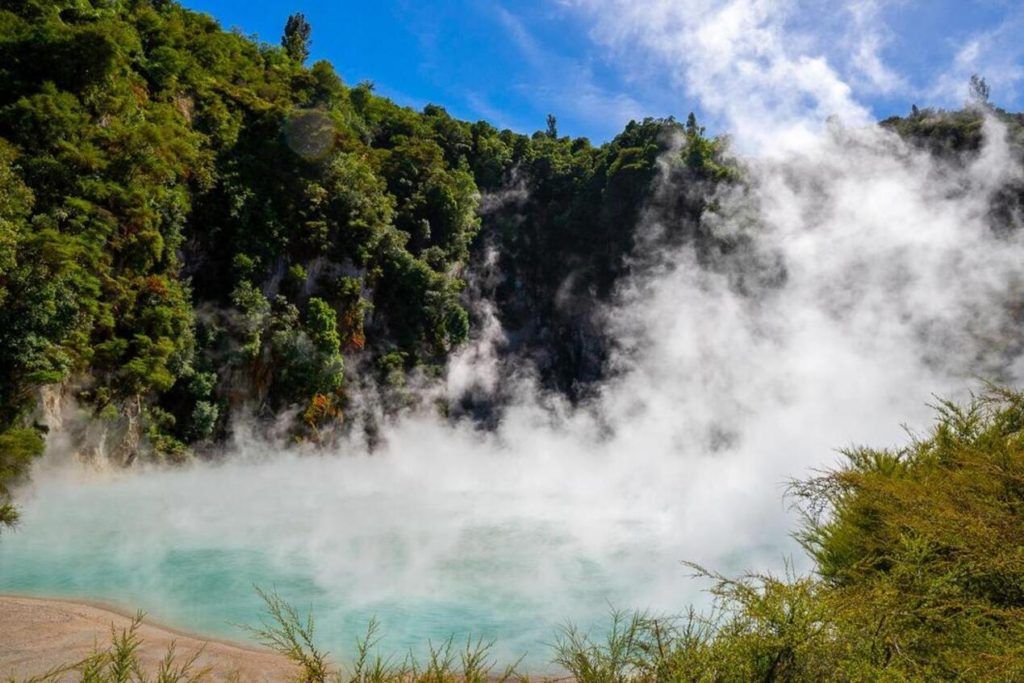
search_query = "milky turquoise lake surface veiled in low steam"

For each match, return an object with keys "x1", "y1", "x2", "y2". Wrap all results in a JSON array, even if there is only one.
[{"x1": 0, "y1": 448, "x2": 784, "y2": 671}]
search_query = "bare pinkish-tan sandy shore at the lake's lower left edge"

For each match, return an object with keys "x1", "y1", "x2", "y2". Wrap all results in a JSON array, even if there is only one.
[{"x1": 0, "y1": 596, "x2": 295, "y2": 683}]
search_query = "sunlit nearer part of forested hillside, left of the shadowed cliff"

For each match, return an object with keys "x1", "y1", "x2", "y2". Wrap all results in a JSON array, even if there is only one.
[{"x1": 0, "y1": 0, "x2": 478, "y2": 457}]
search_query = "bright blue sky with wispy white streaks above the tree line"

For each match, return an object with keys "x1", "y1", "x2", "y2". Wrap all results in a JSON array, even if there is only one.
[{"x1": 184, "y1": 0, "x2": 1024, "y2": 141}]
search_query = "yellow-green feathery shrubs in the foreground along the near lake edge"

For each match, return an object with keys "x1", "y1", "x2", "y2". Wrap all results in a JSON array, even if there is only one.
[{"x1": 14, "y1": 389, "x2": 1024, "y2": 683}]
